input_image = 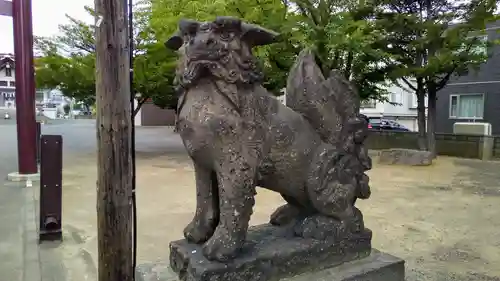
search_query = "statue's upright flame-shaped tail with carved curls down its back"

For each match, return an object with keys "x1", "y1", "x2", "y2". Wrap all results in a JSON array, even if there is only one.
[{"x1": 286, "y1": 49, "x2": 372, "y2": 207}]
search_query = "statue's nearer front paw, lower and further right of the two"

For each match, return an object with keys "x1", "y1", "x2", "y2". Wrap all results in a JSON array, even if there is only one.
[{"x1": 203, "y1": 226, "x2": 243, "y2": 262}]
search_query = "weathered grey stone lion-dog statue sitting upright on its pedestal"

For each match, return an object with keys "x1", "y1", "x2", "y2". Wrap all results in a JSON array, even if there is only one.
[{"x1": 165, "y1": 17, "x2": 371, "y2": 261}]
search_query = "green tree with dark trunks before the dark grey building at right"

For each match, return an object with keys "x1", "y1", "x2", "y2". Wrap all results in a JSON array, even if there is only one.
[{"x1": 376, "y1": 0, "x2": 497, "y2": 155}]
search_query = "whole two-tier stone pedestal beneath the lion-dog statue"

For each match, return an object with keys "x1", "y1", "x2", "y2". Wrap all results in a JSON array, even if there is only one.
[{"x1": 136, "y1": 225, "x2": 404, "y2": 281}]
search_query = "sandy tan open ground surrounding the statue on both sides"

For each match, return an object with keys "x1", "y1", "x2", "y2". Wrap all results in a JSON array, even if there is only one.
[{"x1": 53, "y1": 152, "x2": 500, "y2": 281}]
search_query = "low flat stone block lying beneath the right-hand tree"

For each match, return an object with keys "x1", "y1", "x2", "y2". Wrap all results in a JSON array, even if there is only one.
[{"x1": 379, "y1": 148, "x2": 433, "y2": 166}]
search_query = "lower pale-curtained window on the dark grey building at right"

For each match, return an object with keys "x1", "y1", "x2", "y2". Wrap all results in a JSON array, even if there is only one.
[{"x1": 450, "y1": 94, "x2": 484, "y2": 119}]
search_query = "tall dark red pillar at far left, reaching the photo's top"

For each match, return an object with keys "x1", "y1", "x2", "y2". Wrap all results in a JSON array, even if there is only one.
[{"x1": 12, "y1": 0, "x2": 38, "y2": 175}]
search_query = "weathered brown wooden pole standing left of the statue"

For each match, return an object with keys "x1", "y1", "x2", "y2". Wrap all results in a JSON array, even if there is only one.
[{"x1": 95, "y1": 0, "x2": 134, "y2": 281}]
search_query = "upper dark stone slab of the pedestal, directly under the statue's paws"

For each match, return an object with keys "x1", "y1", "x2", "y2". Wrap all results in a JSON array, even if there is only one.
[{"x1": 170, "y1": 225, "x2": 372, "y2": 281}]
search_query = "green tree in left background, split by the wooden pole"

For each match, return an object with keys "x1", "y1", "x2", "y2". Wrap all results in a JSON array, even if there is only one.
[{"x1": 35, "y1": 4, "x2": 177, "y2": 114}]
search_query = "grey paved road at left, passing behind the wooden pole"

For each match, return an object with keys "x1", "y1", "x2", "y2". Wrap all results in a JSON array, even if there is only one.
[{"x1": 0, "y1": 119, "x2": 184, "y2": 281}]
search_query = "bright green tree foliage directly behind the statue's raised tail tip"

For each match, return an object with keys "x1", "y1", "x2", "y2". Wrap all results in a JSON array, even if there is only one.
[{"x1": 290, "y1": 0, "x2": 391, "y2": 100}]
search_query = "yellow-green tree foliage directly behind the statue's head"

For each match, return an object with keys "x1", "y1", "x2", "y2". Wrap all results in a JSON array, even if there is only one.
[{"x1": 149, "y1": 0, "x2": 299, "y2": 95}]
